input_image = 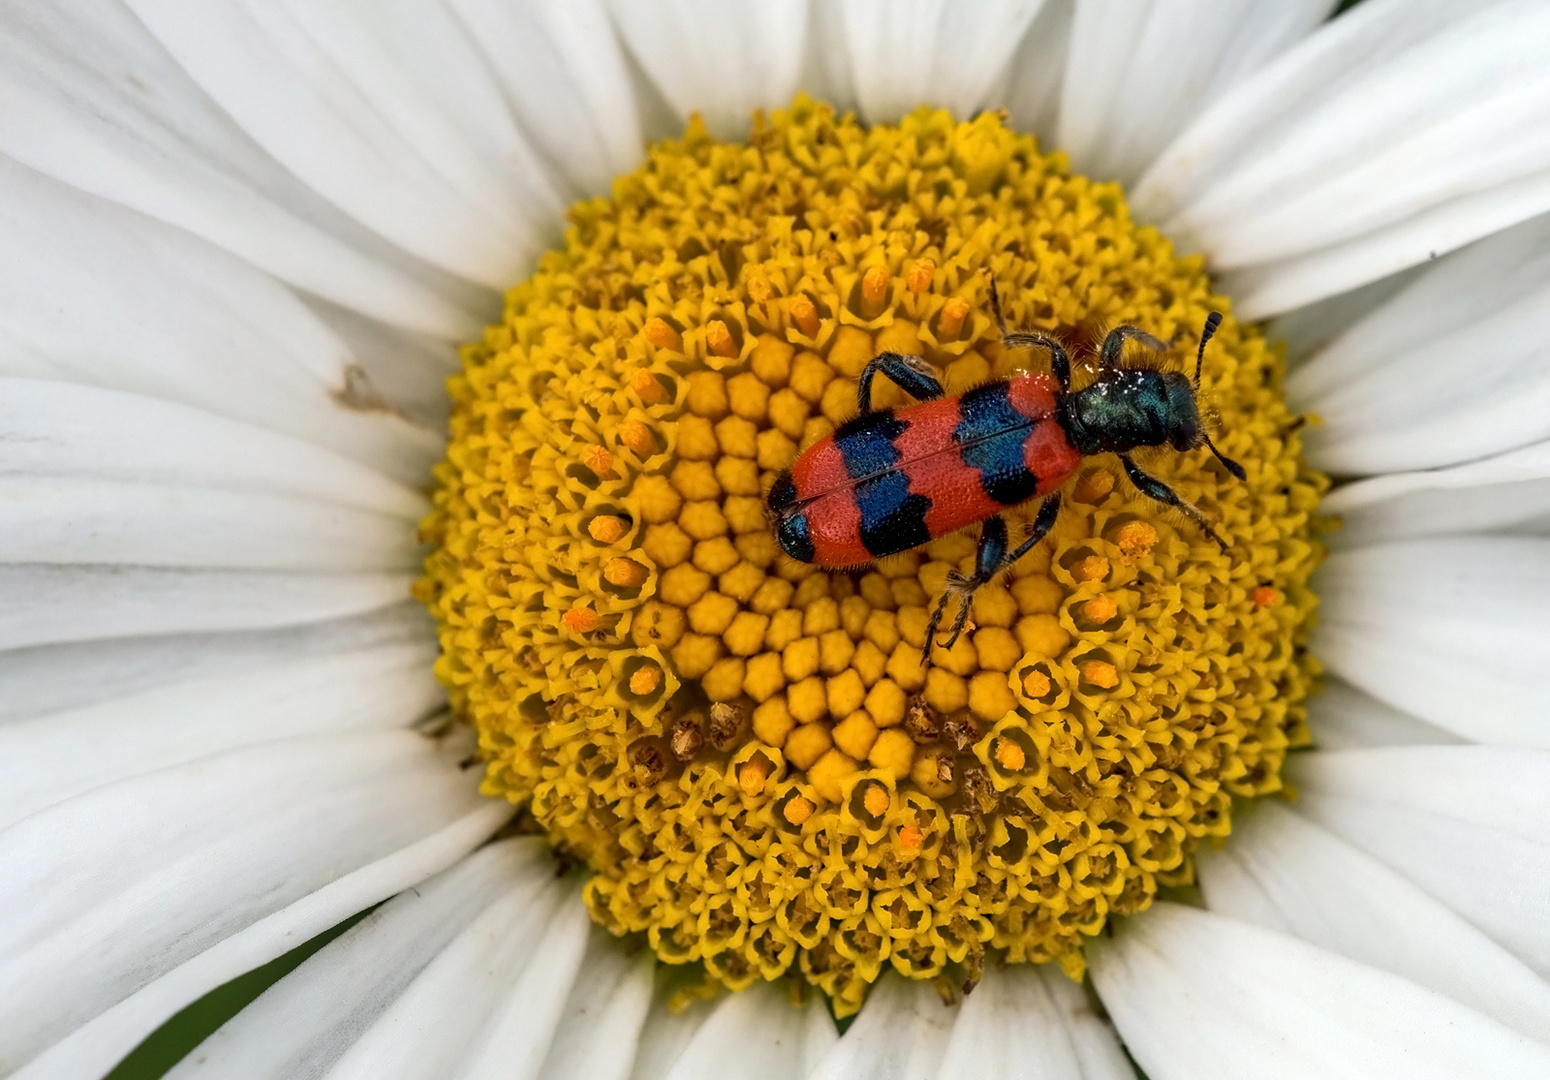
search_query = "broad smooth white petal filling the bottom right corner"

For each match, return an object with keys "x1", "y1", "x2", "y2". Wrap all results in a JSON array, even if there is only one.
[{"x1": 1090, "y1": 903, "x2": 1550, "y2": 1080}]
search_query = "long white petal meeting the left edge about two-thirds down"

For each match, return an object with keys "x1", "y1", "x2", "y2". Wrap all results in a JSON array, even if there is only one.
[{"x1": 0, "y1": 638, "x2": 443, "y2": 829}]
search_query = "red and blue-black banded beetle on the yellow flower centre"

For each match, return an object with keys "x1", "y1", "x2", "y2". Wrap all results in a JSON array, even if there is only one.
[{"x1": 766, "y1": 282, "x2": 1245, "y2": 662}]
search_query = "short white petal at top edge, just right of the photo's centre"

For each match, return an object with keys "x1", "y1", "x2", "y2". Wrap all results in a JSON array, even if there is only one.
[{"x1": 839, "y1": 0, "x2": 1045, "y2": 124}]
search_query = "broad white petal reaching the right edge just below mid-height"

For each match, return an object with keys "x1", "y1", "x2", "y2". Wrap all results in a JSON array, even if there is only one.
[{"x1": 1313, "y1": 536, "x2": 1550, "y2": 747}]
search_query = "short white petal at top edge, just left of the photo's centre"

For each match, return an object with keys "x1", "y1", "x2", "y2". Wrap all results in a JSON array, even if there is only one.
[{"x1": 608, "y1": 0, "x2": 808, "y2": 138}]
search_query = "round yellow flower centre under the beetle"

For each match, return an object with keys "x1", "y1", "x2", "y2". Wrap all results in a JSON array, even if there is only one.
[{"x1": 419, "y1": 99, "x2": 1325, "y2": 1015}]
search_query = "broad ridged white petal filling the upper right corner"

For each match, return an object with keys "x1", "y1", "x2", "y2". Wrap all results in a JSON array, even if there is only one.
[{"x1": 1132, "y1": 0, "x2": 1550, "y2": 319}]
